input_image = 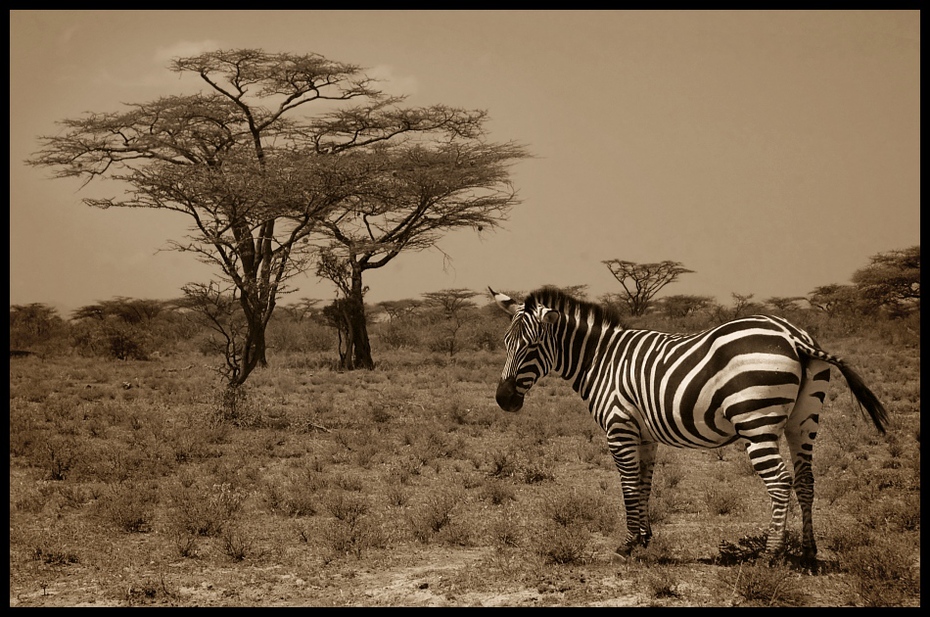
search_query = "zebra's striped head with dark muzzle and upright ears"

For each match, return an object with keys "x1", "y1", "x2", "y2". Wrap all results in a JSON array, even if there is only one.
[{"x1": 488, "y1": 287, "x2": 559, "y2": 411}]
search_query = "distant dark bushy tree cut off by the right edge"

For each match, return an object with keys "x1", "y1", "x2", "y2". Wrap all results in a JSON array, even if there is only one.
[{"x1": 852, "y1": 245, "x2": 920, "y2": 314}]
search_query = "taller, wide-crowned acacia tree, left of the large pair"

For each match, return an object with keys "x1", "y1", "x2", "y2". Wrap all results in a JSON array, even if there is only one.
[{"x1": 27, "y1": 49, "x2": 496, "y2": 386}]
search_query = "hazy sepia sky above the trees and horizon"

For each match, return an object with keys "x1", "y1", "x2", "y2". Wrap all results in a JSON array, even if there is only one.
[{"x1": 10, "y1": 10, "x2": 920, "y2": 316}]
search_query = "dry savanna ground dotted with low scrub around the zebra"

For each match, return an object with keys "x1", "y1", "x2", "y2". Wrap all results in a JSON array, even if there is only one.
[{"x1": 10, "y1": 329, "x2": 920, "y2": 606}]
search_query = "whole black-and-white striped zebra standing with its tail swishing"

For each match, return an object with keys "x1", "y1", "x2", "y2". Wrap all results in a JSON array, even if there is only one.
[{"x1": 488, "y1": 287, "x2": 889, "y2": 565}]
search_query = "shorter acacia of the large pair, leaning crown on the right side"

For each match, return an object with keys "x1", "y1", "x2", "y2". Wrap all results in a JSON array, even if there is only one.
[{"x1": 317, "y1": 138, "x2": 528, "y2": 370}]
